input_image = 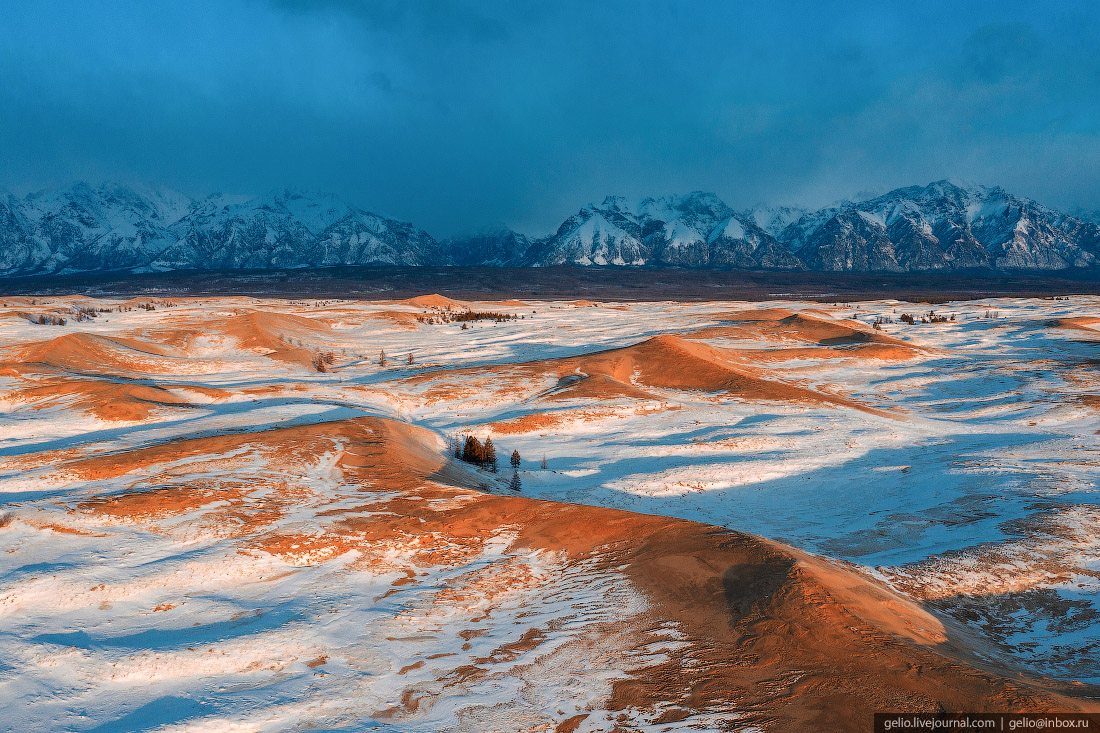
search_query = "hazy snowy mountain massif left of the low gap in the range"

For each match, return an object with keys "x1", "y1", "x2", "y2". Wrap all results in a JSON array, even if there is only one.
[{"x1": 0, "y1": 184, "x2": 439, "y2": 275}]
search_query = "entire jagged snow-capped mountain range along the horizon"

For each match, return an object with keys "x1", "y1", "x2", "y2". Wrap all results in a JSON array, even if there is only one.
[{"x1": 0, "y1": 180, "x2": 1100, "y2": 276}]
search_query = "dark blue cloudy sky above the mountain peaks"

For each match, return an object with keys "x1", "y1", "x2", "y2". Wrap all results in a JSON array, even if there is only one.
[{"x1": 0, "y1": 0, "x2": 1100, "y2": 236}]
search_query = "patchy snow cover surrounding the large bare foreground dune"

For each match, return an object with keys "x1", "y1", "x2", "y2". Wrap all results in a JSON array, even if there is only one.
[{"x1": 0, "y1": 297, "x2": 1100, "y2": 731}]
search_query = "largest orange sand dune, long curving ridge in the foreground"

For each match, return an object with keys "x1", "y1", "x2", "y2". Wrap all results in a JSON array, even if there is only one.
[{"x1": 60, "y1": 418, "x2": 1100, "y2": 731}]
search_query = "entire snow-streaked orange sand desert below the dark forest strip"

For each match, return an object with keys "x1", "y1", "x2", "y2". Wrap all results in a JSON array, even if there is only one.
[{"x1": 0, "y1": 296, "x2": 1100, "y2": 732}]
